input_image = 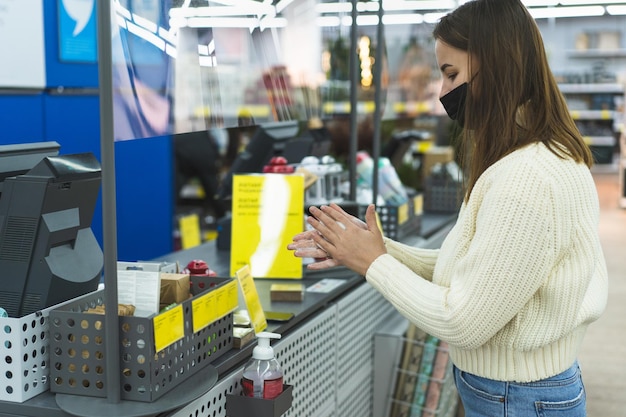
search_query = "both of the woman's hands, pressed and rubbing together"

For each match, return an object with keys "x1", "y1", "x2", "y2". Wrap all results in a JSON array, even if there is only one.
[{"x1": 288, "y1": 204, "x2": 387, "y2": 275}]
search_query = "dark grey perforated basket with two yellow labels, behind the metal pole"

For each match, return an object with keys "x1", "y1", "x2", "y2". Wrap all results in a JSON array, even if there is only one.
[{"x1": 50, "y1": 276, "x2": 237, "y2": 402}]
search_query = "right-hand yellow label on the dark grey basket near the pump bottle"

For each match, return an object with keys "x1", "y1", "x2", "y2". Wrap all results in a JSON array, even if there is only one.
[{"x1": 191, "y1": 280, "x2": 237, "y2": 333}]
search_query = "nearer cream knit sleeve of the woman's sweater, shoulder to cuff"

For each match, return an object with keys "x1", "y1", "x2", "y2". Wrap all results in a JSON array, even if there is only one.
[{"x1": 366, "y1": 164, "x2": 558, "y2": 349}]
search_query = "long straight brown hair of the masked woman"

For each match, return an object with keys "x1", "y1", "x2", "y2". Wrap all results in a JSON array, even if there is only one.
[{"x1": 433, "y1": 0, "x2": 593, "y2": 200}]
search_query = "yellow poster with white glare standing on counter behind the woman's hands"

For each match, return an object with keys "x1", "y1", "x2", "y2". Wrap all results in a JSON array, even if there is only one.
[{"x1": 230, "y1": 174, "x2": 304, "y2": 278}]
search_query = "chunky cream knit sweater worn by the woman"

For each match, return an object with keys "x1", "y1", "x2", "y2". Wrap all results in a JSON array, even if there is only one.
[{"x1": 366, "y1": 144, "x2": 608, "y2": 382}]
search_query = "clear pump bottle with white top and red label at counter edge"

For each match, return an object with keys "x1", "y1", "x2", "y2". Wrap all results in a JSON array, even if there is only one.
[{"x1": 241, "y1": 332, "x2": 283, "y2": 399}]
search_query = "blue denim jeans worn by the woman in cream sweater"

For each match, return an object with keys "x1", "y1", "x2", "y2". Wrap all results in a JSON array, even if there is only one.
[{"x1": 454, "y1": 363, "x2": 587, "y2": 417}]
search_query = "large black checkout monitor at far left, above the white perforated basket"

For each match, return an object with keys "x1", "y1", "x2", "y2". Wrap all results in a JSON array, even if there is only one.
[{"x1": 0, "y1": 149, "x2": 104, "y2": 317}]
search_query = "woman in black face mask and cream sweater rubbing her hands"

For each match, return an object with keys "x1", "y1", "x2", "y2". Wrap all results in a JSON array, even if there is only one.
[{"x1": 289, "y1": 0, "x2": 607, "y2": 417}]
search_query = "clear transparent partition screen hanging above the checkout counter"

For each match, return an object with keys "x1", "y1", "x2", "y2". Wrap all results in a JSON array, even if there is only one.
[{"x1": 113, "y1": 0, "x2": 454, "y2": 140}]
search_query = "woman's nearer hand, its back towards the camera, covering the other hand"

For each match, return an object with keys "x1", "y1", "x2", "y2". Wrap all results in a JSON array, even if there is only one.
[{"x1": 307, "y1": 204, "x2": 387, "y2": 276}]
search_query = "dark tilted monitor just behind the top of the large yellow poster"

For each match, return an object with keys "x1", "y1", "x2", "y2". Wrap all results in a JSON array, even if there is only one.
[{"x1": 218, "y1": 120, "x2": 300, "y2": 200}]
